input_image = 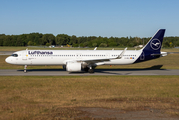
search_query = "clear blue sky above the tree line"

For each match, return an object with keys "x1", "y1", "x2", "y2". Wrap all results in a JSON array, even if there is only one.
[{"x1": 0, "y1": 0, "x2": 179, "y2": 38}]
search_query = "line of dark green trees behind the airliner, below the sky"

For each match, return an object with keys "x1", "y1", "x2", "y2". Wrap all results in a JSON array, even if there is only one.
[{"x1": 0, "y1": 33, "x2": 179, "y2": 48}]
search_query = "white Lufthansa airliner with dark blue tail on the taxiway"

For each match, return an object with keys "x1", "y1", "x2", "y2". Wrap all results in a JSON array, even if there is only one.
[{"x1": 5, "y1": 29, "x2": 167, "y2": 73}]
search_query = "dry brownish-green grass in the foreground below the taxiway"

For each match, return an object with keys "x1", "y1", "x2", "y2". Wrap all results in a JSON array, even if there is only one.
[{"x1": 0, "y1": 76, "x2": 179, "y2": 120}]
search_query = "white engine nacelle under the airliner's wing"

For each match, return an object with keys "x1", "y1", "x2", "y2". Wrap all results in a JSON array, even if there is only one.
[{"x1": 66, "y1": 61, "x2": 81, "y2": 72}]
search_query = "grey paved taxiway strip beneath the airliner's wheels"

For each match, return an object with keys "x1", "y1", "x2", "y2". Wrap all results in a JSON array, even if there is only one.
[{"x1": 0, "y1": 69, "x2": 179, "y2": 76}]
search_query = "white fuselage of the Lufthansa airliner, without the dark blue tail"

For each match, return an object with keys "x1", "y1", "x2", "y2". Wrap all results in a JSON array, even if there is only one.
[{"x1": 6, "y1": 50, "x2": 142, "y2": 65}]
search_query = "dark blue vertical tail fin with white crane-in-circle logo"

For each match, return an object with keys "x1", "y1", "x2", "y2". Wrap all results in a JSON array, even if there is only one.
[{"x1": 143, "y1": 29, "x2": 165, "y2": 53}]
